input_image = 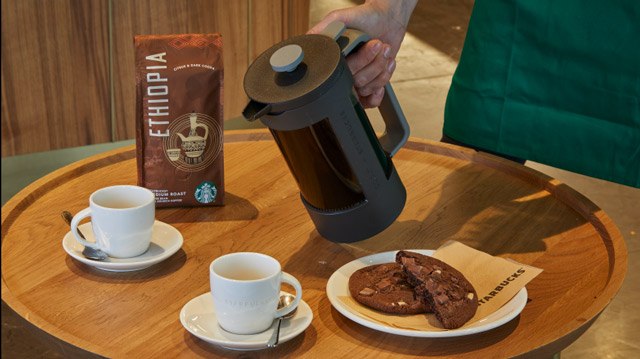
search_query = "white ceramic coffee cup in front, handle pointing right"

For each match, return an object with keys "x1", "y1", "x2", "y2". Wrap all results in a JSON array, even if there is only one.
[{"x1": 209, "y1": 252, "x2": 302, "y2": 334}]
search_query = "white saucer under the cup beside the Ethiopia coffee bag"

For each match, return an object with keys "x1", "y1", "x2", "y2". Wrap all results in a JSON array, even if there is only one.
[{"x1": 62, "y1": 220, "x2": 183, "y2": 272}]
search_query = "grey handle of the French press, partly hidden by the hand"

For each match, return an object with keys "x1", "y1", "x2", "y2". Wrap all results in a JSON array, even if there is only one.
[{"x1": 321, "y1": 21, "x2": 410, "y2": 157}]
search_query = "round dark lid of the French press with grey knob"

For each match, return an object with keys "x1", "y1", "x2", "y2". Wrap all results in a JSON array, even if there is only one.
[{"x1": 244, "y1": 34, "x2": 346, "y2": 121}]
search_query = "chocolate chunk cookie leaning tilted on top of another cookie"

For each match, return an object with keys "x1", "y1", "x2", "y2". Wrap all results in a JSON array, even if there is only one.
[{"x1": 396, "y1": 251, "x2": 478, "y2": 329}]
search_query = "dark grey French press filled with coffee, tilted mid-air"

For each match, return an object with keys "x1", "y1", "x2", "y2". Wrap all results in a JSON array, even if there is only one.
[{"x1": 242, "y1": 22, "x2": 409, "y2": 243}]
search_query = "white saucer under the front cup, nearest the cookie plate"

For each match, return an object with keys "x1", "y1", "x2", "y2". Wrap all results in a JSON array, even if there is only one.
[{"x1": 180, "y1": 292, "x2": 313, "y2": 350}]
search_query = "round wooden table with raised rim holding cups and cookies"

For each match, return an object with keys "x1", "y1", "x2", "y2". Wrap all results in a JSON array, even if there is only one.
[{"x1": 2, "y1": 131, "x2": 627, "y2": 359}]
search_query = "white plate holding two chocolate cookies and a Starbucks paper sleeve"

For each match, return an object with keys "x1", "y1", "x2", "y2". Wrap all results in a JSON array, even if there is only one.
[{"x1": 327, "y1": 250, "x2": 527, "y2": 338}]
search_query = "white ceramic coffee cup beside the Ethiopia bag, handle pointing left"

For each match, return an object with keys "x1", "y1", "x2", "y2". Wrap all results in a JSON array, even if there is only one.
[{"x1": 71, "y1": 185, "x2": 156, "y2": 258}]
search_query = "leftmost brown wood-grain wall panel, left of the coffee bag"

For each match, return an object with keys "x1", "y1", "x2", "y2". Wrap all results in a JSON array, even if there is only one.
[{"x1": 1, "y1": 0, "x2": 111, "y2": 157}]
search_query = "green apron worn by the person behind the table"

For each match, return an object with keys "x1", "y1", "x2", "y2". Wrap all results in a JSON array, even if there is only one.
[{"x1": 443, "y1": 0, "x2": 640, "y2": 187}]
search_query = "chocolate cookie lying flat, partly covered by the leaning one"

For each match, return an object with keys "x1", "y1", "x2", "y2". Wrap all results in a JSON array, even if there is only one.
[{"x1": 349, "y1": 263, "x2": 427, "y2": 314}]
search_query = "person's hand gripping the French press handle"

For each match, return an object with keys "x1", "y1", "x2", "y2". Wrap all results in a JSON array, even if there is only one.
[{"x1": 308, "y1": 0, "x2": 417, "y2": 108}]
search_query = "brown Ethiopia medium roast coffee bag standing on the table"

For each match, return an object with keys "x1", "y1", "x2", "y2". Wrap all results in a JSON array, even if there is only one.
[{"x1": 134, "y1": 34, "x2": 225, "y2": 207}]
